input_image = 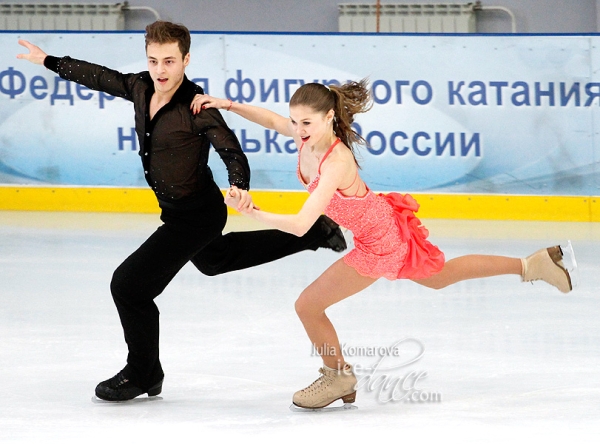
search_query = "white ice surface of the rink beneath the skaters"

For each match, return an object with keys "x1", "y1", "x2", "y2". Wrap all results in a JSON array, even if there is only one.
[{"x1": 0, "y1": 212, "x2": 600, "y2": 444}]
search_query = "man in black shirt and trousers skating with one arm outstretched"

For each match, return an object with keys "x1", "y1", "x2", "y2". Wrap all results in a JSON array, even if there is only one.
[{"x1": 17, "y1": 21, "x2": 346, "y2": 401}]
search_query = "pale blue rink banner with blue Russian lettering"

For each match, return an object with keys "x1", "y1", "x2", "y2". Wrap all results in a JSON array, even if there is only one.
[{"x1": 0, "y1": 32, "x2": 600, "y2": 220}]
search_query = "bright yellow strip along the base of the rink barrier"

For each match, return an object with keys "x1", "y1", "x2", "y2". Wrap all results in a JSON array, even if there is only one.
[{"x1": 0, "y1": 186, "x2": 600, "y2": 222}]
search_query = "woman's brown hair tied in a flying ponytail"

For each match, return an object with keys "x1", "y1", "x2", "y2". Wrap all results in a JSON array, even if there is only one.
[{"x1": 290, "y1": 79, "x2": 373, "y2": 163}]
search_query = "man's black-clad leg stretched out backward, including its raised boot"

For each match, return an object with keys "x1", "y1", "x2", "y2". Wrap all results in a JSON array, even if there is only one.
[{"x1": 192, "y1": 216, "x2": 346, "y2": 276}]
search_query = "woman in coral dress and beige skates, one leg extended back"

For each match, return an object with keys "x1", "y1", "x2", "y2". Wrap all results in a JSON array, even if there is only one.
[{"x1": 192, "y1": 80, "x2": 572, "y2": 409}]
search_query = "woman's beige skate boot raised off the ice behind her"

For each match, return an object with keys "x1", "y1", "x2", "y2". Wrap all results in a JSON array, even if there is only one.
[{"x1": 521, "y1": 241, "x2": 577, "y2": 293}]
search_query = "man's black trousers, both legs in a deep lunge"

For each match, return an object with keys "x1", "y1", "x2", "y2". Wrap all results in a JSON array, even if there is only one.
[{"x1": 111, "y1": 186, "x2": 328, "y2": 389}]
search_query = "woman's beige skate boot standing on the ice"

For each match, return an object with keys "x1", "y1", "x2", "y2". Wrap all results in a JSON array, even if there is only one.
[{"x1": 290, "y1": 364, "x2": 356, "y2": 412}]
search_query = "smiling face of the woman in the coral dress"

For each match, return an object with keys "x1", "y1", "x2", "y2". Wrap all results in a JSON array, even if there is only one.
[{"x1": 290, "y1": 105, "x2": 334, "y2": 147}]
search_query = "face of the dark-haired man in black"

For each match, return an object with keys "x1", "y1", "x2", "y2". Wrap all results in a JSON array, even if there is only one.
[{"x1": 146, "y1": 42, "x2": 190, "y2": 95}]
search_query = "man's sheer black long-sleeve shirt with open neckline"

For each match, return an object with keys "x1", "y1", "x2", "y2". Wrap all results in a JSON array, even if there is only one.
[{"x1": 44, "y1": 56, "x2": 250, "y2": 205}]
